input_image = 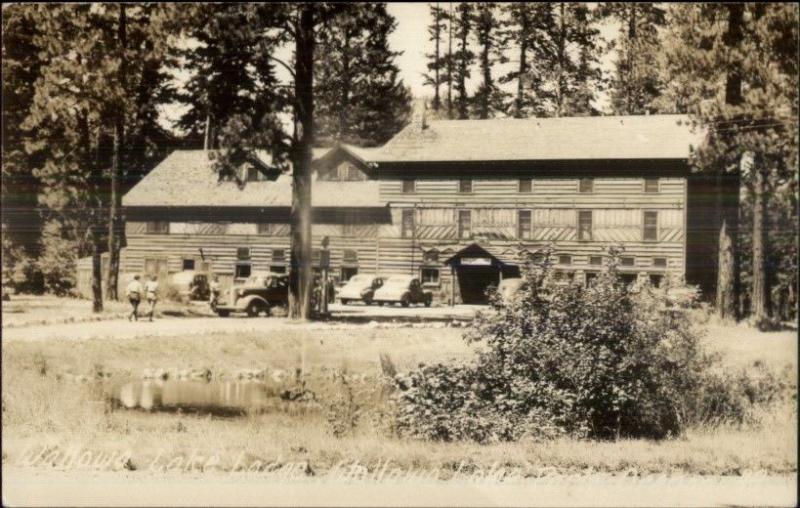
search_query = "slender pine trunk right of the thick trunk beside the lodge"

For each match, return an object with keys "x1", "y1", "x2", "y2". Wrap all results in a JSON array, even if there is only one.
[{"x1": 751, "y1": 159, "x2": 769, "y2": 324}]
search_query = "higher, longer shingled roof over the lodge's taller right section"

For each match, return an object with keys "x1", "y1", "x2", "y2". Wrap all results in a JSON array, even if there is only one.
[{"x1": 369, "y1": 115, "x2": 702, "y2": 164}]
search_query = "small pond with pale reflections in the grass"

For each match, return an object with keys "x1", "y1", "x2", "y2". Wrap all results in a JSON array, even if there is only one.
[{"x1": 107, "y1": 380, "x2": 278, "y2": 414}]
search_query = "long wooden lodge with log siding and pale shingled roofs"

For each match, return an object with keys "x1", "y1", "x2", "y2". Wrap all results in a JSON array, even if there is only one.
[{"x1": 83, "y1": 115, "x2": 702, "y2": 303}]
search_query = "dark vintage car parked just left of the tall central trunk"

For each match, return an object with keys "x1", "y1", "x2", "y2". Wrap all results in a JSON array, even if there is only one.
[{"x1": 216, "y1": 272, "x2": 289, "y2": 317}]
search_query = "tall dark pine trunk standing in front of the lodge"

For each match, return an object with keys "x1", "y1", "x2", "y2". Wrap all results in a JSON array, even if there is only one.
[{"x1": 289, "y1": 3, "x2": 314, "y2": 320}]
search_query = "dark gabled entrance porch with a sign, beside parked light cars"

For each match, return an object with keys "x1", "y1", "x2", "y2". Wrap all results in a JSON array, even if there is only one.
[{"x1": 445, "y1": 243, "x2": 519, "y2": 305}]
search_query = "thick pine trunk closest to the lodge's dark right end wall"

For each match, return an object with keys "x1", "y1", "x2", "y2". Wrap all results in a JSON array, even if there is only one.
[{"x1": 717, "y1": 4, "x2": 744, "y2": 319}]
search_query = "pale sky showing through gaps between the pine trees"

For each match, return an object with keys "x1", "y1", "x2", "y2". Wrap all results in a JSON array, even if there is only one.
[{"x1": 160, "y1": 2, "x2": 617, "y2": 130}]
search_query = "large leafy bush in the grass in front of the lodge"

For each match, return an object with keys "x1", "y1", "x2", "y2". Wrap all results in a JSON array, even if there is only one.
[{"x1": 396, "y1": 249, "x2": 708, "y2": 442}]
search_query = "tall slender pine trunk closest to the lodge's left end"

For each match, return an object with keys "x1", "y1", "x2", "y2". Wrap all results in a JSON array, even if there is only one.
[{"x1": 106, "y1": 4, "x2": 127, "y2": 300}]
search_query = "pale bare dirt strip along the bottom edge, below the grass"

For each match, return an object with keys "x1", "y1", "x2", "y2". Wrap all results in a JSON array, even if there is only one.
[{"x1": 3, "y1": 468, "x2": 797, "y2": 506}]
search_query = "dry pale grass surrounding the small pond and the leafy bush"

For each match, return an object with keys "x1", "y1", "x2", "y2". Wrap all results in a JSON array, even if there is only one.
[{"x1": 2, "y1": 327, "x2": 797, "y2": 478}]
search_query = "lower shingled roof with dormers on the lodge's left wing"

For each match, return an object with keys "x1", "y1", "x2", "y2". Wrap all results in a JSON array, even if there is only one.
[{"x1": 122, "y1": 149, "x2": 385, "y2": 207}]
